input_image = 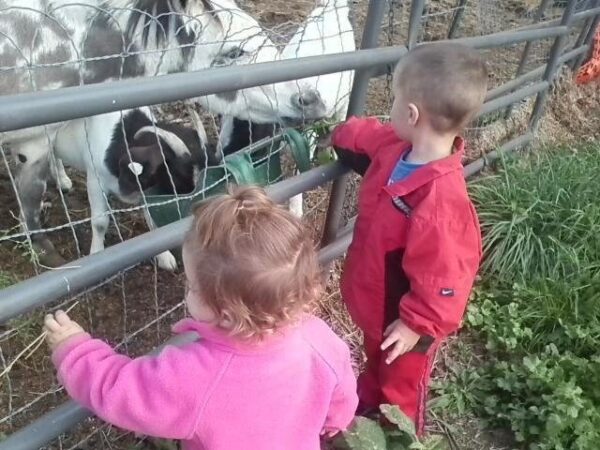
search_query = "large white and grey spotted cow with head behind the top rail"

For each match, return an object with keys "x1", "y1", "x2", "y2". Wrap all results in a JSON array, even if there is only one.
[{"x1": 0, "y1": 0, "x2": 325, "y2": 266}]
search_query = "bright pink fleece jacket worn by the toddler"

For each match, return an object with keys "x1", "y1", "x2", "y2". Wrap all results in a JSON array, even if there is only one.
[{"x1": 52, "y1": 316, "x2": 358, "y2": 450}]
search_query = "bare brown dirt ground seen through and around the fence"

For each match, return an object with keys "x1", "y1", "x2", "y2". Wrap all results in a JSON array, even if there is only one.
[{"x1": 0, "y1": 0, "x2": 600, "y2": 450}]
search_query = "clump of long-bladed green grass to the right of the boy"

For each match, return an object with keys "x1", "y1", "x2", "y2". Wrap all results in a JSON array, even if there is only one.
[{"x1": 470, "y1": 147, "x2": 600, "y2": 281}]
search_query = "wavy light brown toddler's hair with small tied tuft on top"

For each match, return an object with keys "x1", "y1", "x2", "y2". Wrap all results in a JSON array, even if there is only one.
[{"x1": 184, "y1": 186, "x2": 321, "y2": 338}]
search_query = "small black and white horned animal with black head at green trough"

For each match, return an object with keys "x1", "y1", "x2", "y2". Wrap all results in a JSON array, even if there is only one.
[{"x1": 54, "y1": 108, "x2": 218, "y2": 270}]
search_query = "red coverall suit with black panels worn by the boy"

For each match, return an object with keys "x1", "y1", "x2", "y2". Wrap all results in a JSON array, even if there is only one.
[{"x1": 332, "y1": 117, "x2": 481, "y2": 432}]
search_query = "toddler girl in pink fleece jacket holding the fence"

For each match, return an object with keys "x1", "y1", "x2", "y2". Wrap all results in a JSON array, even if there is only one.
[{"x1": 45, "y1": 187, "x2": 358, "y2": 450}]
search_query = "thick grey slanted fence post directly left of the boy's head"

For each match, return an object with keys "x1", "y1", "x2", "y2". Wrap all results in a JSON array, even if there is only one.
[{"x1": 321, "y1": 0, "x2": 388, "y2": 246}]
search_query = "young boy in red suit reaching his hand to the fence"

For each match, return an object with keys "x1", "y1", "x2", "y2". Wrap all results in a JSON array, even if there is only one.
[{"x1": 331, "y1": 43, "x2": 487, "y2": 432}]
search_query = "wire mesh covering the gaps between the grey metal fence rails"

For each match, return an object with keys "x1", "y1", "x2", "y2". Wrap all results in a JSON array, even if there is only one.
[{"x1": 0, "y1": 0, "x2": 594, "y2": 449}]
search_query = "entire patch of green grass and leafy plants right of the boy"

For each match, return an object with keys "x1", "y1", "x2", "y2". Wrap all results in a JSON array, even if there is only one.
[{"x1": 434, "y1": 146, "x2": 600, "y2": 450}]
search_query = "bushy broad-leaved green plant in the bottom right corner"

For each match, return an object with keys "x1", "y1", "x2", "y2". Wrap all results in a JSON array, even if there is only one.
[{"x1": 475, "y1": 345, "x2": 600, "y2": 450}]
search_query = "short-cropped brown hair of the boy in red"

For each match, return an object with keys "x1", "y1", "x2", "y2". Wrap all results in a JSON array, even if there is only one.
[{"x1": 394, "y1": 42, "x2": 487, "y2": 133}]
